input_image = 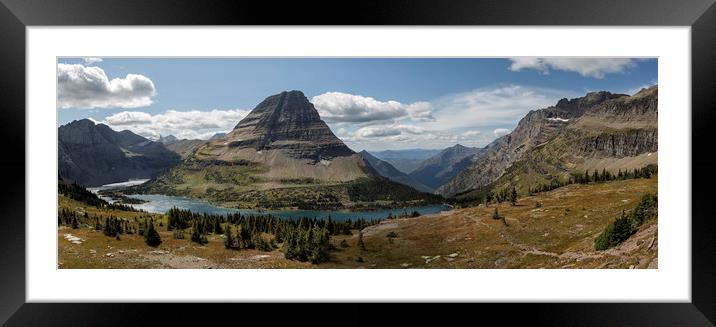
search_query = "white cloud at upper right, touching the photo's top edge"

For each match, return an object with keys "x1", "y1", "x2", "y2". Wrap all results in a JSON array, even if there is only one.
[{"x1": 510, "y1": 57, "x2": 636, "y2": 79}]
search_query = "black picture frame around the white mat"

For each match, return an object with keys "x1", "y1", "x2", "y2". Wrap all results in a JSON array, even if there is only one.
[{"x1": 0, "y1": 0, "x2": 716, "y2": 326}]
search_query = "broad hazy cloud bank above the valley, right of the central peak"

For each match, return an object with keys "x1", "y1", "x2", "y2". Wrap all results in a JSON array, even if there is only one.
[{"x1": 316, "y1": 85, "x2": 579, "y2": 150}]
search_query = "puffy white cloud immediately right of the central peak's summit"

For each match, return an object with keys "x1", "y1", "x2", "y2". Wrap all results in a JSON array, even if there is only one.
[{"x1": 311, "y1": 92, "x2": 435, "y2": 123}]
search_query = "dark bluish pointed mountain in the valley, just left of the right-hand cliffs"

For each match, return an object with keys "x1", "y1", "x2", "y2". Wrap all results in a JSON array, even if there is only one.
[{"x1": 409, "y1": 144, "x2": 484, "y2": 191}]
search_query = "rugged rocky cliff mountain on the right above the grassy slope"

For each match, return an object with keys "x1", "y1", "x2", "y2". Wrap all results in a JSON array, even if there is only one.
[{"x1": 438, "y1": 87, "x2": 658, "y2": 196}]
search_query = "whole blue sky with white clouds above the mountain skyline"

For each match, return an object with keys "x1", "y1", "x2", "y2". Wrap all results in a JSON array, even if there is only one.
[{"x1": 58, "y1": 58, "x2": 657, "y2": 151}]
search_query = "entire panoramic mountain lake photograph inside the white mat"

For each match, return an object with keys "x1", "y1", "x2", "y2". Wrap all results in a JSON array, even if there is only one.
[{"x1": 56, "y1": 57, "x2": 658, "y2": 269}]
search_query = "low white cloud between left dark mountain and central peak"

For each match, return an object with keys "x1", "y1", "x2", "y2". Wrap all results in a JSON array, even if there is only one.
[{"x1": 100, "y1": 109, "x2": 249, "y2": 139}]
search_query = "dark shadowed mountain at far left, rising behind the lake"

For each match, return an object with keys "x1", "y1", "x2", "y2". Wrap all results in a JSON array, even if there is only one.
[{"x1": 58, "y1": 119, "x2": 181, "y2": 186}]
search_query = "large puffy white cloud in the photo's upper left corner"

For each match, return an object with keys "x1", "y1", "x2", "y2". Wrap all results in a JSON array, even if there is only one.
[{"x1": 57, "y1": 64, "x2": 157, "y2": 109}]
